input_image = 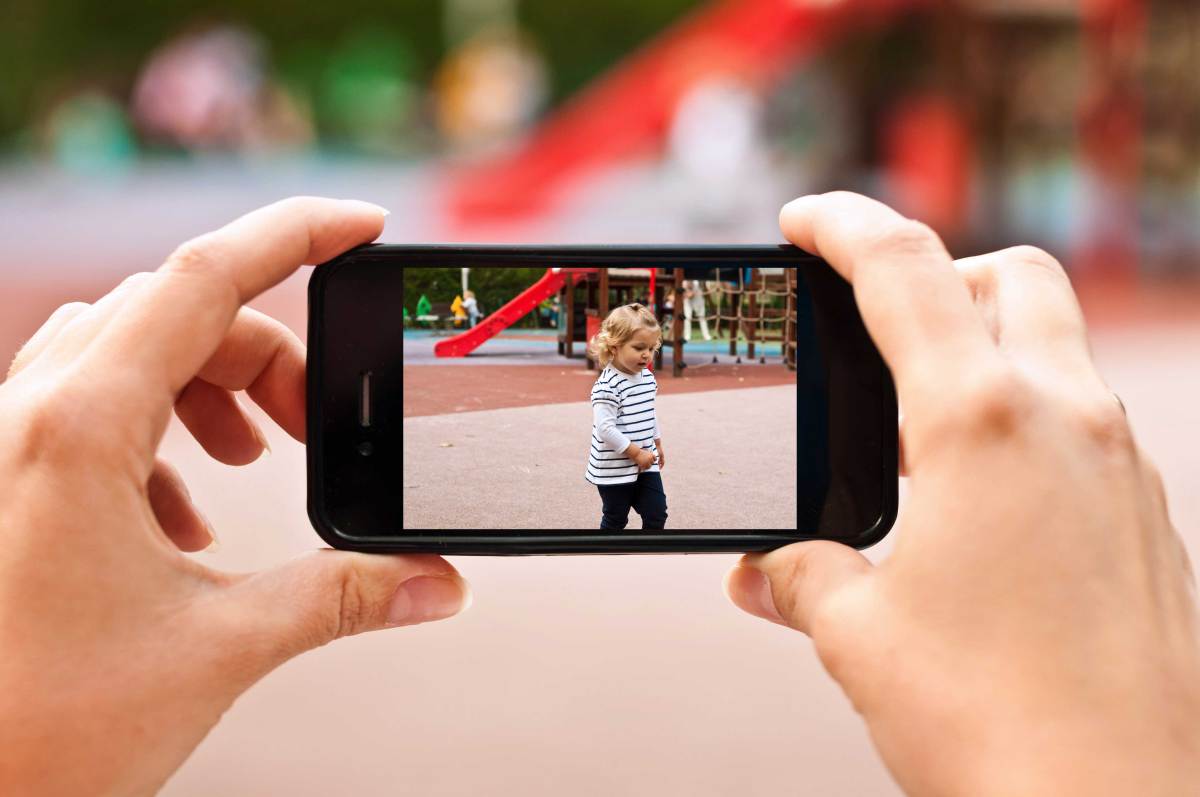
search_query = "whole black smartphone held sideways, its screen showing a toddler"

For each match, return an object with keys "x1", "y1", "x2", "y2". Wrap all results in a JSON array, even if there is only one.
[{"x1": 308, "y1": 245, "x2": 896, "y2": 552}]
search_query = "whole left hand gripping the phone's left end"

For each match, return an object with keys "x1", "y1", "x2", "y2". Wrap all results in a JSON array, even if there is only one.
[{"x1": 0, "y1": 198, "x2": 467, "y2": 795}]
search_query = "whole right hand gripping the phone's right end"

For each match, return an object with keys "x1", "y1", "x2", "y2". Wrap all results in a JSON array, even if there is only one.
[{"x1": 726, "y1": 193, "x2": 1200, "y2": 795}]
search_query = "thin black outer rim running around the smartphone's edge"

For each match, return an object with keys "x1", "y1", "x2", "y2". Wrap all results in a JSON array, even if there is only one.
[{"x1": 307, "y1": 244, "x2": 899, "y2": 556}]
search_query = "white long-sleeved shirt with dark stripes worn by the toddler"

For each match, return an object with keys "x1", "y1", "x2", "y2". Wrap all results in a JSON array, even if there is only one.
[{"x1": 584, "y1": 365, "x2": 662, "y2": 485}]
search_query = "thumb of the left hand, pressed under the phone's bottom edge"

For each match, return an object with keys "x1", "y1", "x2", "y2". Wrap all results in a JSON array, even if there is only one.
[{"x1": 208, "y1": 550, "x2": 470, "y2": 677}]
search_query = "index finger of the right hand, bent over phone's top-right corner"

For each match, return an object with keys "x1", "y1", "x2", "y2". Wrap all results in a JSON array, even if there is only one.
[{"x1": 779, "y1": 191, "x2": 1000, "y2": 405}]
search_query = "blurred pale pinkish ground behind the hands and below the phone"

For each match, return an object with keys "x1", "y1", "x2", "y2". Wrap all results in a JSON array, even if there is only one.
[{"x1": 163, "y1": 316, "x2": 1200, "y2": 797}]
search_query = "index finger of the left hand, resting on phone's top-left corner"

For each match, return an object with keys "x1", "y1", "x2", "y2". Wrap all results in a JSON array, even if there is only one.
[{"x1": 79, "y1": 197, "x2": 386, "y2": 463}]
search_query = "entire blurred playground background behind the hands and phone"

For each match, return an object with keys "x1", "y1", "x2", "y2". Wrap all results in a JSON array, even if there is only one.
[{"x1": 0, "y1": 0, "x2": 1200, "y2": 795}]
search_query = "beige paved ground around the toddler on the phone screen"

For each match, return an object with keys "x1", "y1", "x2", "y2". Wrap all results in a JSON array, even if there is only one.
[{"x1": 403, "y1": 385, "x2": 796, "y2": 529}]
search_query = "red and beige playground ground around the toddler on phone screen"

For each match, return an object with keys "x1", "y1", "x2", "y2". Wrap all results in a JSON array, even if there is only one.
[{"x1": 403, "y1": 330, "x2": 797, "y2": 529}]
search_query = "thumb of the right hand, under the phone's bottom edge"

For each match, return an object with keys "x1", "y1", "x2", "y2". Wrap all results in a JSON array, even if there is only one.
[{"x1": 725, "y1": 540, "x2": 872, "y2": 636}]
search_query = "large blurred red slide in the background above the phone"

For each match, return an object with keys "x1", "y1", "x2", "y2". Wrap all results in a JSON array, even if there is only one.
[{"x1": 448, "y1": 0, "x2": 928, "y2": 224}]
